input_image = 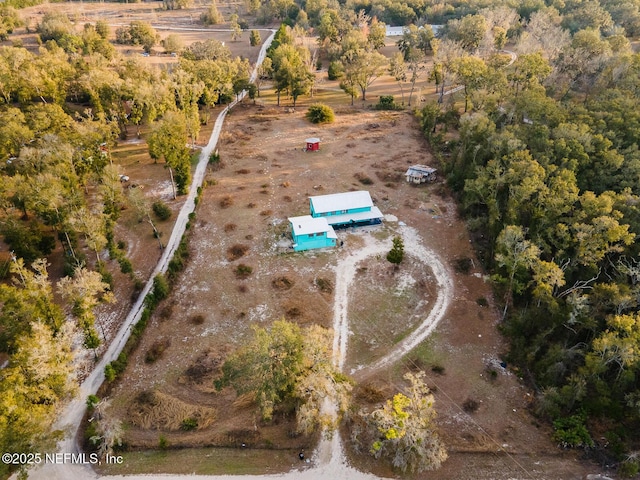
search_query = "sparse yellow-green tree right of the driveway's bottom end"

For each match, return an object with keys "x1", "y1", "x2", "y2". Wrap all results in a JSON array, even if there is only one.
[{"x1": 367, "y1": 372, "x2": 447, "y2": 472}]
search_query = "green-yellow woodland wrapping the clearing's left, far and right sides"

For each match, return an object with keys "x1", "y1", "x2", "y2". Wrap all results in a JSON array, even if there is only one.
[{"x1": 0, "y1": 0, "x2": 640, "y2": 474}]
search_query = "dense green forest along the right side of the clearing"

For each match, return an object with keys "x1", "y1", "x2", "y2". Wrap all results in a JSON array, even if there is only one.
[{"x1": 419, "y1": 2, "x2": 640, "y2": 473}]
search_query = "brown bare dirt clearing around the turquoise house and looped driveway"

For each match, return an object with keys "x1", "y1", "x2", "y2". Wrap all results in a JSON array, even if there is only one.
[{"x1": 101, "y1": 105, "x2": 604, "y2": 478}]
